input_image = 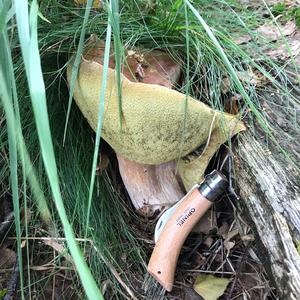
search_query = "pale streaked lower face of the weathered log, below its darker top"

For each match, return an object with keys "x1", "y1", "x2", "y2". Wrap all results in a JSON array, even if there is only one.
[{"x1": 235, "y1": 128, "x2": 300, "y2": 299}]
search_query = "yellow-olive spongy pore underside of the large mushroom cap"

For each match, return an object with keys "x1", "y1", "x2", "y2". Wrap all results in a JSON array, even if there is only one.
[{"x1": 67, "y1": 38, "x2": 245, "y2": 213}]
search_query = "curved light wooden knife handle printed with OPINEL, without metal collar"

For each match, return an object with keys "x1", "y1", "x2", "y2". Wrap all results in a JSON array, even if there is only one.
[{"x1": 147, "y1": 187, "x2": 213, "y2": 292}]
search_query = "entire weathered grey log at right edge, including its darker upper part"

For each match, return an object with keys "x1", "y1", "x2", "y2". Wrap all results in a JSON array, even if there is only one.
[{"x1": 235, "y1": 82, "x2": 300, "y2": 299}]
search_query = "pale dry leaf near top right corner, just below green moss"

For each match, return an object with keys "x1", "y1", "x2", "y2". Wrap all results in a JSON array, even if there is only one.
[{"x1": 256, "y1": 21, "x2": 296, "y2": 42}]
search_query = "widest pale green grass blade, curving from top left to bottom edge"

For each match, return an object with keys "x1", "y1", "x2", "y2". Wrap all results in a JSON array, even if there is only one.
[{"x1": 16, "y1": 1, "x2": 103, "y2": 299}]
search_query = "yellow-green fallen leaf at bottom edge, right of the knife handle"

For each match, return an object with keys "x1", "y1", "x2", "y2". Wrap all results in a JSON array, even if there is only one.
[{"x1": 194, "y1": 274, "x2": 230, "y2": 300}]
